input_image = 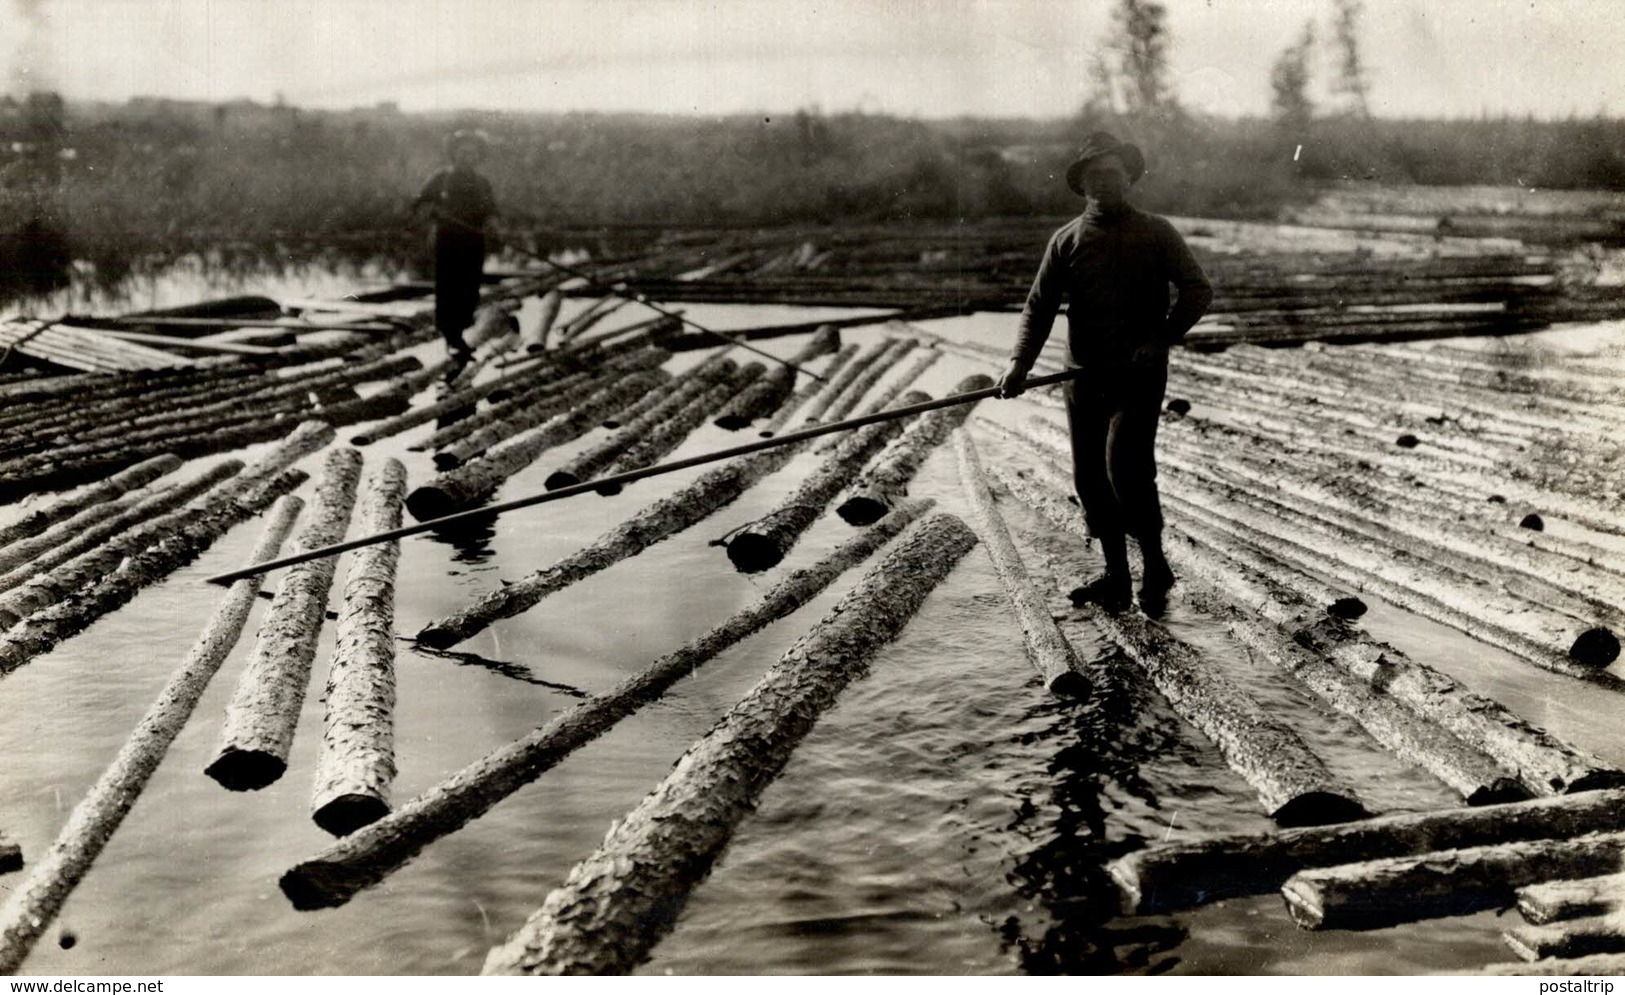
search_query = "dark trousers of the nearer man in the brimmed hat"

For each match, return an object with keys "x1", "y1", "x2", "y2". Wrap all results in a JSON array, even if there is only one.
[{"x1": 1066, "y1": 364, "x2": 1168, "y2": 564}]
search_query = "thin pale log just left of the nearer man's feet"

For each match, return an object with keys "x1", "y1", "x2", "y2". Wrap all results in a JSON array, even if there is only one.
[{"x1": 955, "y1": 423, "x2": 1090, "y2": 697}]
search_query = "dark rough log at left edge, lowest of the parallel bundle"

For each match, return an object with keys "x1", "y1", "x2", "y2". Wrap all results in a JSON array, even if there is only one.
[{"x1": 0, "y1": 470, "x2": 309, "y2": 675}]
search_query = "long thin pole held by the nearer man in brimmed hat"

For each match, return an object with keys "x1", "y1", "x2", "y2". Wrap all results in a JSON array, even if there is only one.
[{"x1": 208, "y1": 369, "x2": 1082, "y2": 584}]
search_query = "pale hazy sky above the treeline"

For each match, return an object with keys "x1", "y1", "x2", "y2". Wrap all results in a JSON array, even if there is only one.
[{"x1": 0, "y1": 0, "x2": 1625, "y2": 117}]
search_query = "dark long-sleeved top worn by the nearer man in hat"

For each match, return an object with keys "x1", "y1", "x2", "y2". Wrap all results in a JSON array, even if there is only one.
[{"x1": 1011, "y1": 206, "x2": 1212, "y2": 367}]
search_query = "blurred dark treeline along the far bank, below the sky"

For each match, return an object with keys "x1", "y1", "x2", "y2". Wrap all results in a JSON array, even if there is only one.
[{"x1": 0, "y1": 101, "x2": 1625, "y2": 278}]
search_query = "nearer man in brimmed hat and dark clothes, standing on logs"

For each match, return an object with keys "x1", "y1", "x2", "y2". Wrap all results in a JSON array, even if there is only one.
[{"x1": 999, "y1": 132, "x2": 1212, "y2": 615}]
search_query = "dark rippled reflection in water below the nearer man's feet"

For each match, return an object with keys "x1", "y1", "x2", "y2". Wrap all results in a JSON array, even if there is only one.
[{"x1": 1001, "y1": 654, "x2": 1186, "y2": 974}]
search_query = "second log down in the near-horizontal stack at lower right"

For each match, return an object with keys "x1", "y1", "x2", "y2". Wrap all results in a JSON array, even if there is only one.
[{"x1": 1281, "y1": 829, "x2": 1625, "y2": 930}]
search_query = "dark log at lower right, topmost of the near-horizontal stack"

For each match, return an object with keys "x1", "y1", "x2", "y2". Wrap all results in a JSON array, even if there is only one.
[{"x1": 1107, "y1": 790, "x2": 1625, "y2": 915}]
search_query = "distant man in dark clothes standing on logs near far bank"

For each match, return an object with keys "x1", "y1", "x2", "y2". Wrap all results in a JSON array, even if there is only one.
[{"x1": 413, "y1": 128, "x2": 497, "y2": 363}]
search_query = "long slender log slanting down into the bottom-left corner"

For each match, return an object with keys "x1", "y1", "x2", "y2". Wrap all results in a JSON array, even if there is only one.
[{"x1": 0, "y1": 496, "x2": 304, "y2": 974}]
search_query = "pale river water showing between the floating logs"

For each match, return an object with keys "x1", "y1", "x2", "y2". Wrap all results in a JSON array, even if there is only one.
[{"x1": 0, "y1": 268, "x2": 1625, "y2": 975}]
